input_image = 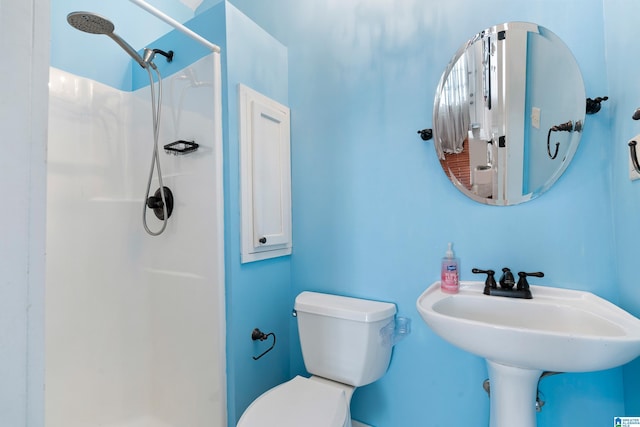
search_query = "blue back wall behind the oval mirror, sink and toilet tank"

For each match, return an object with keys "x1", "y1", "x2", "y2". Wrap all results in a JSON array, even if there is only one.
[{"x1": 234, "y1": 0, "x2": 637, "y2": 427}]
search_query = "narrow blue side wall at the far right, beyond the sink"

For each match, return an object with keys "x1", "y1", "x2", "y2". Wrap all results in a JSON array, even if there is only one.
[{"x1": 602, "y1": 0, "x2": 640, "y2": 416}]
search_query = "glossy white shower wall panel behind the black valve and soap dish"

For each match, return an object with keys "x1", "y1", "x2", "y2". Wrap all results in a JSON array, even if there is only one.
[{"x1": 132, "y1": 55, "x2": 226, "y2": 427}]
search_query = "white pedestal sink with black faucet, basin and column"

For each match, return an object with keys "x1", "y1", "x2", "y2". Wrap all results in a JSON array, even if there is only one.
[{"x1": 417, "y1": 282, "x2": 640, "y2": 427}]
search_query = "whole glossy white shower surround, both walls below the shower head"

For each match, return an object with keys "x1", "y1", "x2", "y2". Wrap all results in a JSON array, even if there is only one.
[{"x1": 45, "y1": 53, "x2": 226, "y2": 427}]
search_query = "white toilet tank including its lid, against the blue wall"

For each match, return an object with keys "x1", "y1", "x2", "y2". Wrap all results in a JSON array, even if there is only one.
[{"x1": 295, "y1": 292, "x2": 396, "y2": 387}]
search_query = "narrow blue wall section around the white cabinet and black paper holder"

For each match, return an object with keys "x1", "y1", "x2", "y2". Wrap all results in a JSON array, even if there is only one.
[{"x1": 220, "y1": 3, "x2": 292, "y2": 426}]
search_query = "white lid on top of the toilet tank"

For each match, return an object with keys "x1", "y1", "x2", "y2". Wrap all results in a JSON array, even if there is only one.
[{"x1": 294, "y1": 291, "x2": 396, "y2": 323}]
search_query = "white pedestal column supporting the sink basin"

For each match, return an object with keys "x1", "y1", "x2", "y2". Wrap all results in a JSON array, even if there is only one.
[{"x1": 487, "y1": 360, "x2": 542, "y2": 427}]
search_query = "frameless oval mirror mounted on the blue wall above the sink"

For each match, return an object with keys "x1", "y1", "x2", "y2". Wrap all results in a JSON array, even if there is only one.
[{"x1": 433, "y1": 22, "x2": 586, "y2": 205}]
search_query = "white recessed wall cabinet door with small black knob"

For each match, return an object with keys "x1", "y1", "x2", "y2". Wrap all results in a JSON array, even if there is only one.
[{"x1": 238, "y1": 85, "x2": 292, "y2": 263}]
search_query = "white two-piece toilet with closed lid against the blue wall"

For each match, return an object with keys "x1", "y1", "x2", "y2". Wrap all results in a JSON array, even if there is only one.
[{"x1": 237, "y1": 292, "x2": 396, "y2": 427}]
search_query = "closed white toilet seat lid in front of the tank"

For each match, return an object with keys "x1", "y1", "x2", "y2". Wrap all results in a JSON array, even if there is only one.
[{"x1": 237, "y1": 376, "x2": 351, "y2": 427}]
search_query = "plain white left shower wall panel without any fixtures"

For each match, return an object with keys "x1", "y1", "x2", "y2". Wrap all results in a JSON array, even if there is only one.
[{"x1": 46, "y1": 69, "x2": 151, "y2": 427}]
